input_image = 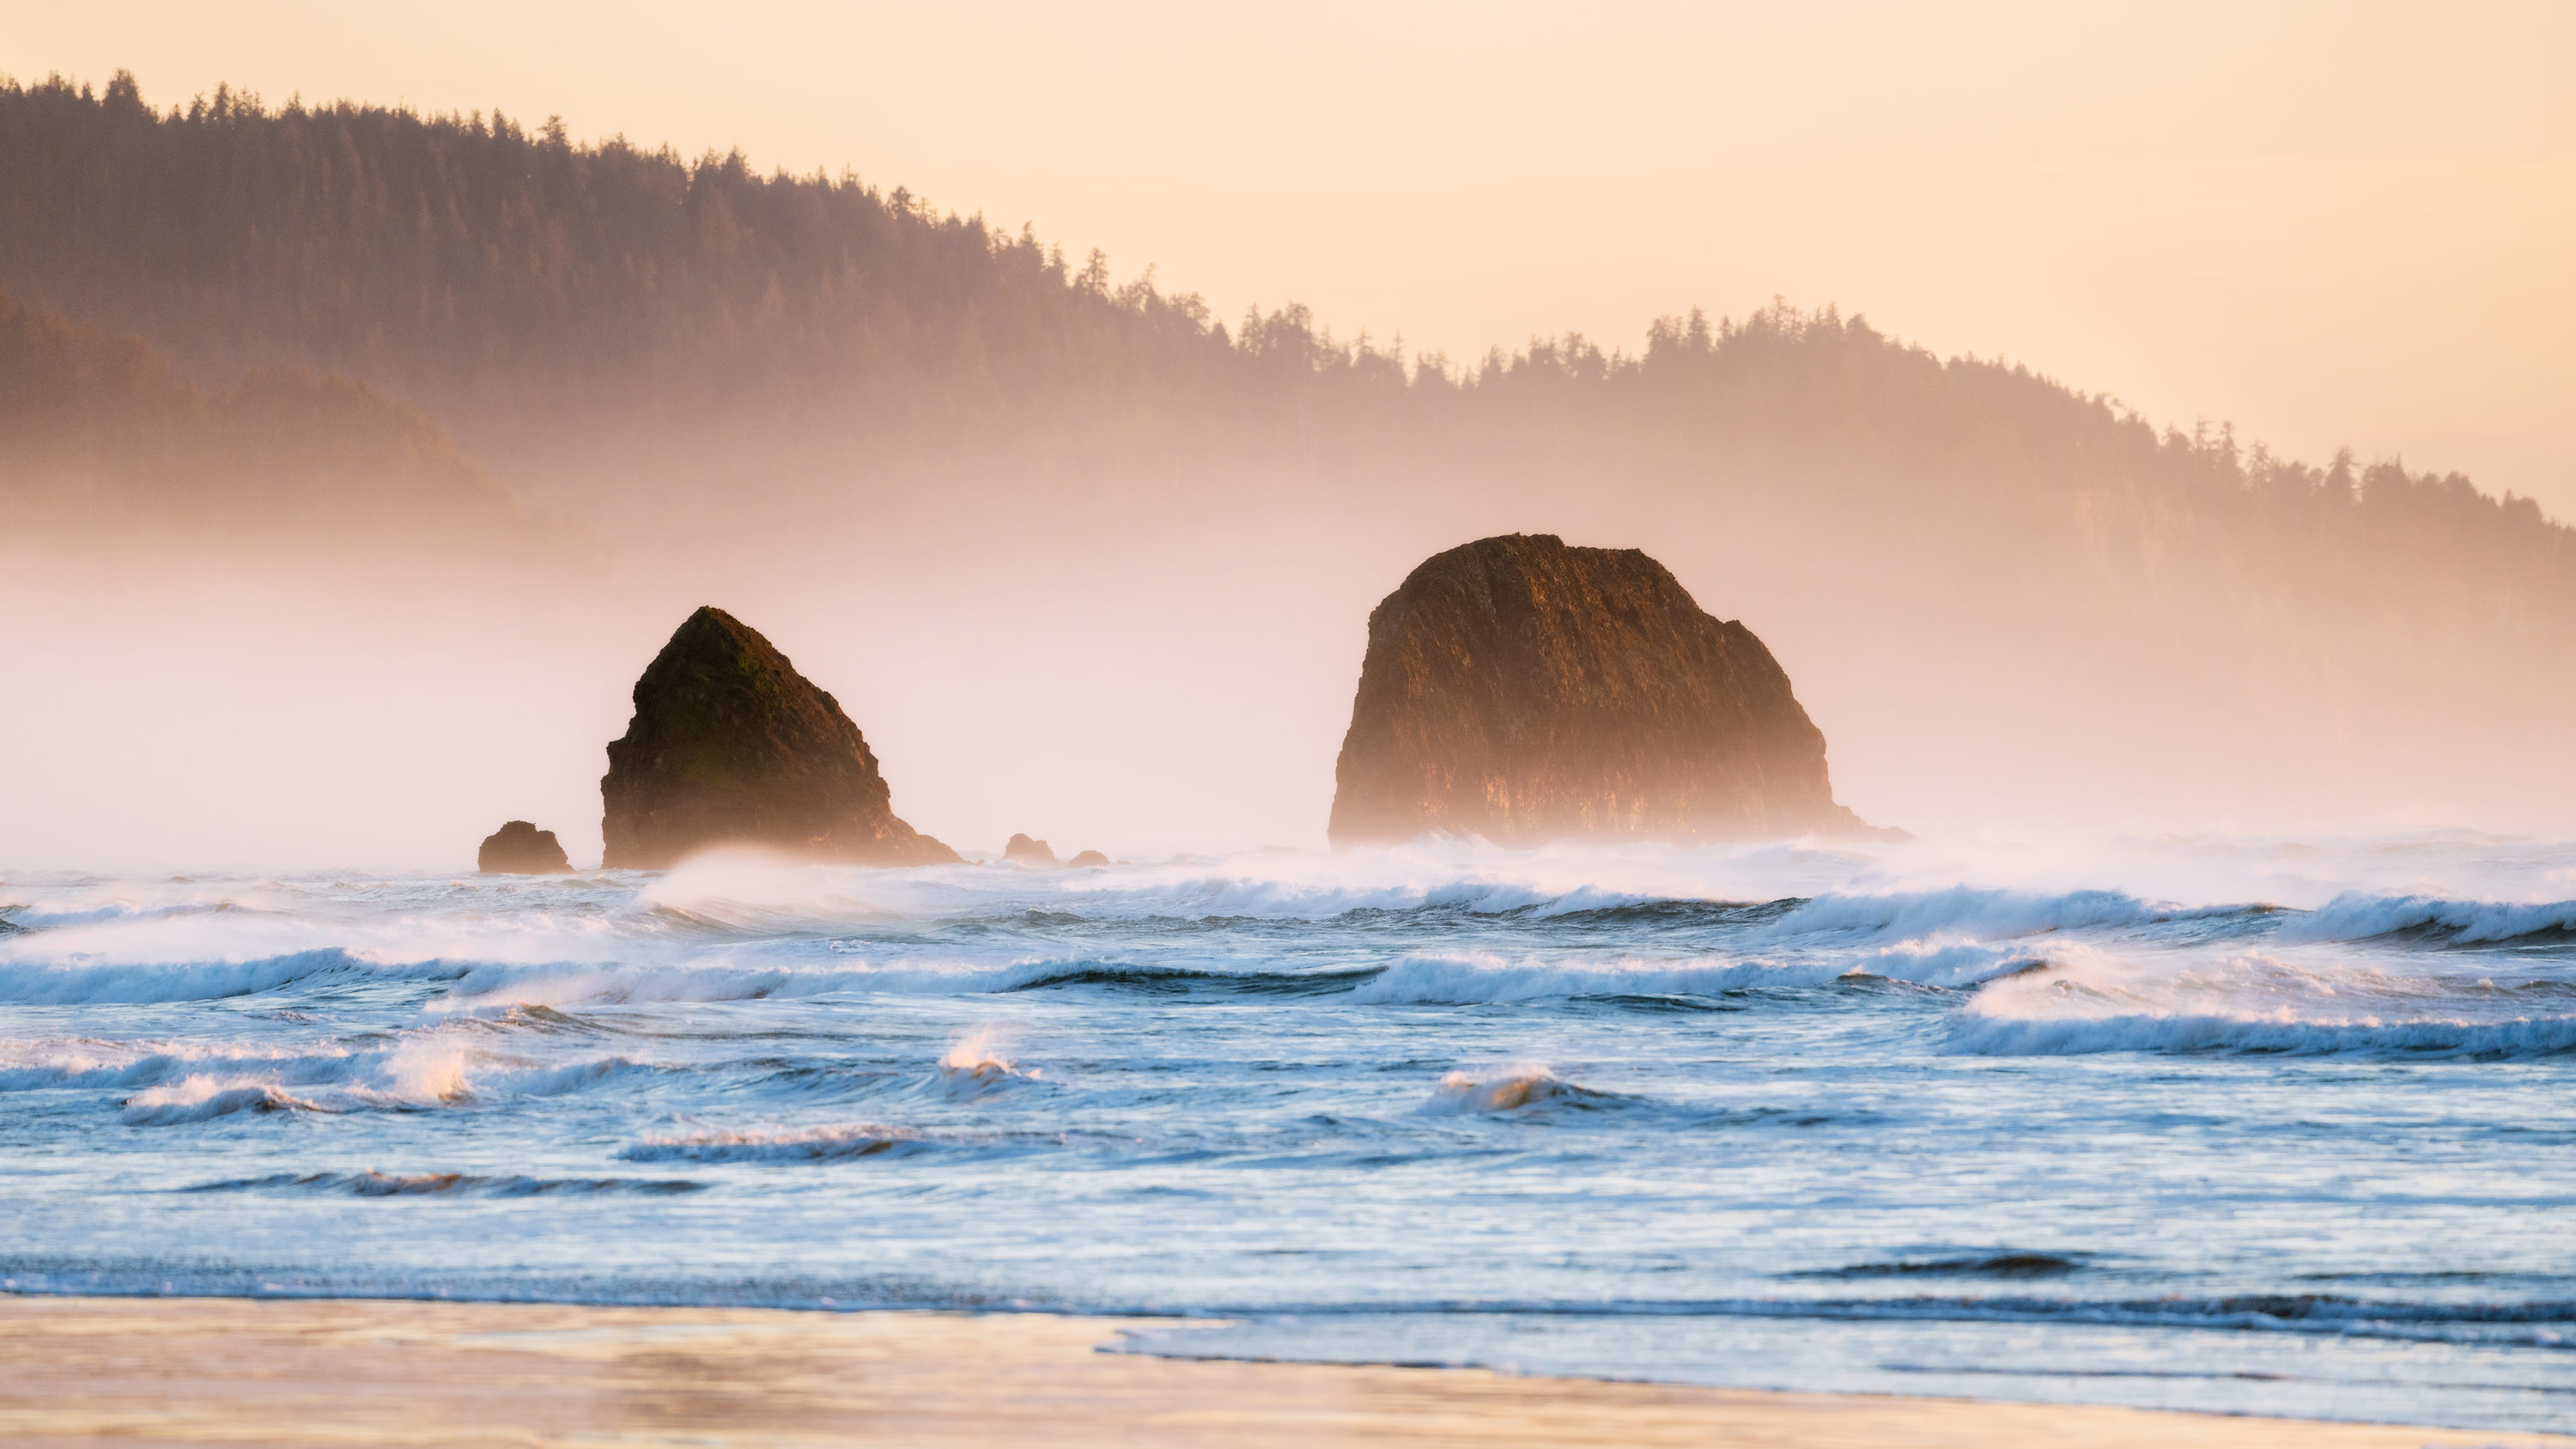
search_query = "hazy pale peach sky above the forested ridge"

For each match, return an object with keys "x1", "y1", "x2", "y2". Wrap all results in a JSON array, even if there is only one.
[{"x1": 20, "y1": 0, "x2": 2576, "y2": 518}]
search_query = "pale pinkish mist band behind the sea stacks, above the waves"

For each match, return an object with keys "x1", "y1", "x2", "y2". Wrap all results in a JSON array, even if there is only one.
[{"x1": 20, "y1": 407, "x2": 2576, "y2": 869}]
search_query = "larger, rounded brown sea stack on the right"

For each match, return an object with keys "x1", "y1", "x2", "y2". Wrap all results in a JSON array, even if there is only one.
[{"x1": 1329, "y1": 533, "x2": 1870, "y2": 846}]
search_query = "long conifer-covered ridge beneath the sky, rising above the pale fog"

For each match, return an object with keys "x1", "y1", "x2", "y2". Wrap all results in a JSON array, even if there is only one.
[{"x1": 0, "y1": 75, "x2": 2576, "y2": 814}]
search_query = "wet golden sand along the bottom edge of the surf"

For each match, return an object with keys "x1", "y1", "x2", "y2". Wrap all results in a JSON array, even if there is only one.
[{"x1": 0, "y1": 1297, "x2": 2576, "y2": 1449}]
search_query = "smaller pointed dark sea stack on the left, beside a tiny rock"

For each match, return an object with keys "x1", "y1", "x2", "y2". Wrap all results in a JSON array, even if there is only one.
[{"x1": 600, "y1": 608, "x2": 958, "y2": 872}]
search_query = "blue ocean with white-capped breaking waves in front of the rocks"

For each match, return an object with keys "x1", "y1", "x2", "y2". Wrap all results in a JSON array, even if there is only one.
[{"x1": 0, "y1": 833, "x2": 2576, "y2": 1431}]
